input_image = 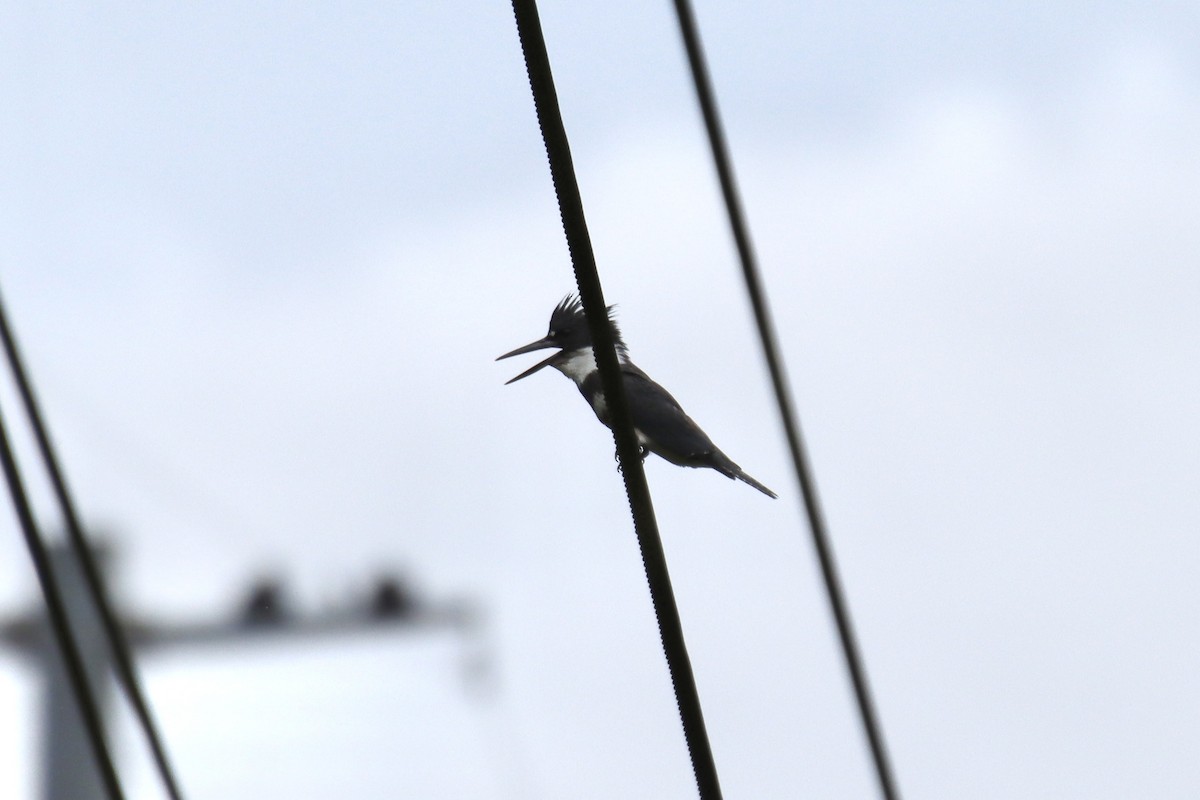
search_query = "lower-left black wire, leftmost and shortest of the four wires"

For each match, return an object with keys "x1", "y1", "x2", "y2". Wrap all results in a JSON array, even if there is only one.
[{"x1": 0, "y1": 398, "x2": 125, "y2": 800}]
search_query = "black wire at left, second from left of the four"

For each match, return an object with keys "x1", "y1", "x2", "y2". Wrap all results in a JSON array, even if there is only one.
[{"x1": 0, "y1": 291, "x2": 182, "y2": 800}]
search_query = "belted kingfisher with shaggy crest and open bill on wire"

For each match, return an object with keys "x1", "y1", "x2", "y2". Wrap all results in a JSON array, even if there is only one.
[{"x1": 497, "y1": 295, "x2": 778, "y2": 498}]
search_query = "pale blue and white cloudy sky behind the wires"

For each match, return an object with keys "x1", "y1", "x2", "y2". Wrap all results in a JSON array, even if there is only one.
[{"x1": 0, "y1": 1, "x2": 1200, "y2": 800}]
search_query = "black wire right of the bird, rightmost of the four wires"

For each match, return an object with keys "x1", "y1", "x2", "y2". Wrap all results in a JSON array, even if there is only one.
[{"x1": 674, "y1": 0, "x2": 900, "y2": 800}]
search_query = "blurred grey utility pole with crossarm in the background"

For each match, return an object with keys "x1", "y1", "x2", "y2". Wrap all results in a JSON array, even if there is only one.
[{"x1": 0, "y1": 545, "x2": 478, "y2": 800}]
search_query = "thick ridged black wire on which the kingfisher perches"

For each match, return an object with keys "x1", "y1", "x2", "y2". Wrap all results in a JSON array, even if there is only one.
[{"x1": 512, "y1": 0, "x2": 721, "y2": 800}]
